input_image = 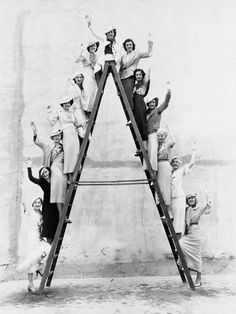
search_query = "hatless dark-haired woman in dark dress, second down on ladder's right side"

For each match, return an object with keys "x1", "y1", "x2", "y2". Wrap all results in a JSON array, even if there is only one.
[{"x1": 133, "y1": 69, "x2": 150, "y2": 156}]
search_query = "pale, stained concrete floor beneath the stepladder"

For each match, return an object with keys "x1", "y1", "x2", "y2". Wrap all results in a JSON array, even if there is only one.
[{"x1": 0, "y1": 276, "x2": 236, "y2": 314}]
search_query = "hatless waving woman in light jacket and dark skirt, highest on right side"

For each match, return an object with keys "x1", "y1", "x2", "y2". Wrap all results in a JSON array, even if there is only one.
[{"x1": 120, "y1": 34, "x2": 153, "y2": 110}]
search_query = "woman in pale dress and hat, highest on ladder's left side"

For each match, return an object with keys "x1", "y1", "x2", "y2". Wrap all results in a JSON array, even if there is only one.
[{"x1": 74, "y1": 40, "x2": 99, "y2": 118}]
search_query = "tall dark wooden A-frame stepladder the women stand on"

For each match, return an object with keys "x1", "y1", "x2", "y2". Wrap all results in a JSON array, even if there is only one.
[{"x1": 39, "y1": 61, "x2": 195, "y2": 294}]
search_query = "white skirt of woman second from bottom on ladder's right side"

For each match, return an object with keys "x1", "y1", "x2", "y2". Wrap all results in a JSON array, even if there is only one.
[{"x1": 171, "y1": 195, "x2": 186, "y2": 234}]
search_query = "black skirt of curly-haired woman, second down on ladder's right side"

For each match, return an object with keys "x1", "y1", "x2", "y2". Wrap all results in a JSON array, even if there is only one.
[{"x1": 133, "y1": 93, "x2": 148, "y2": 141}]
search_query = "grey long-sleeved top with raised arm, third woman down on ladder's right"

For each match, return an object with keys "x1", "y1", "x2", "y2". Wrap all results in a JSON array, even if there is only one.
[{"x1": 147, "y1": 92, "x2": 171, "y2": 134}]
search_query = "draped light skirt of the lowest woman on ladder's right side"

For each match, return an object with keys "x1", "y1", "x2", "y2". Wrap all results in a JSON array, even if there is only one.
[{"x1": 178, "y1": 225, "x2": 202, "y2": 273}]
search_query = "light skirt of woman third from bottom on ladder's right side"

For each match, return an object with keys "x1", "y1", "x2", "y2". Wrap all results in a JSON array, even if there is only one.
[{"x1": 157, "y1": 161, "x2": 172, "y2": 205}]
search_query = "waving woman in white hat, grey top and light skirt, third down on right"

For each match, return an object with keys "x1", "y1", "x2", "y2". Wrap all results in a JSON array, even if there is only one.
[{"x1": 146, "y1": 89, "x2": 171, "y2": 173}]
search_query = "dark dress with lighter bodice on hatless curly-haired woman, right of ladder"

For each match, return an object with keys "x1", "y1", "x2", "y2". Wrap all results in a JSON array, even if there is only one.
[{"x1": 133, "y1": 78, "x2": 149, "y2": 141}]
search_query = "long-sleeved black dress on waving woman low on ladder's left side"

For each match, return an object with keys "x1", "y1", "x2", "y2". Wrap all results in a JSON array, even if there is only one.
[{"x1": 27, "y1": 168, "x2": 59, "y2": 240}]
